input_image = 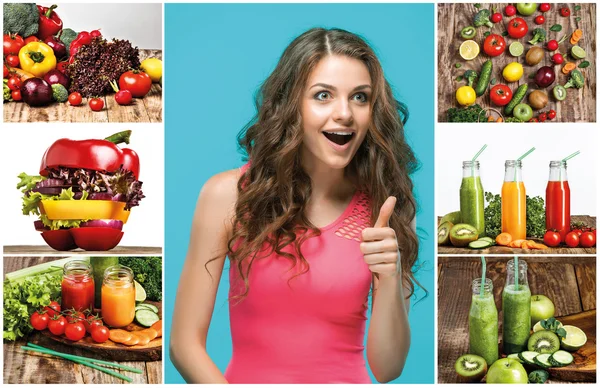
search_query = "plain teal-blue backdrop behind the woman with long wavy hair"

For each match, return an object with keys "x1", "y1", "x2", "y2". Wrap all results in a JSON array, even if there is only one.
[{"x1": 163, "y1": 4, "x2": 436, "y2": 383}]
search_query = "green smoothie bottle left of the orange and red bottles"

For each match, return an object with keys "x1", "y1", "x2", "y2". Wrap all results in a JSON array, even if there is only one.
[{"x1": 460, "y1": 160, "x2": 485, "y2": 237}]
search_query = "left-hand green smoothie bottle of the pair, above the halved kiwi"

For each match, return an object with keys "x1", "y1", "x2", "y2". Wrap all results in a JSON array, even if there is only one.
[{"x1": 469, "y1": 278, "x2": 498, "y2": 365}]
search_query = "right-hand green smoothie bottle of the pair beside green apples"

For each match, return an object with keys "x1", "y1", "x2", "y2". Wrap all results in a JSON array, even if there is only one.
[{"x1": 502, "y1": 260, "x2": 531, "y2": 354}]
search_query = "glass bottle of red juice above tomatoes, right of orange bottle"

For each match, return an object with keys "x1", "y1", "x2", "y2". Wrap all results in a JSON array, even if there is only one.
[{"x1": 546, "y1": 160, "x2": 571, "y2": 242}]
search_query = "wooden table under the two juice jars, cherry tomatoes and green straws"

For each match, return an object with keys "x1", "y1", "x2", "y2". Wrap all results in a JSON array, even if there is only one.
[{"x1": 4, "y1": 257, "x2": 162, "y2": 384}]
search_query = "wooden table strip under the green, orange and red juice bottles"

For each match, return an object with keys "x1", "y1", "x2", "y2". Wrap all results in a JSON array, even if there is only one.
[{"x1": 438, "y1": 216, "x2": 596, "y2": 256}]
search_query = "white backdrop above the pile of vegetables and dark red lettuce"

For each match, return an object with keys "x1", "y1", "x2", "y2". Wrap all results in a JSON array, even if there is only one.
[{"x1": 52, "y1": 2, "x2": 163, "y2": 49}]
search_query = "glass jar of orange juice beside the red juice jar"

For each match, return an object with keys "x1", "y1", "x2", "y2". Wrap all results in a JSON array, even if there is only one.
[{"x1": 101, "y1": 265, "x2": 135, "y2": 327}]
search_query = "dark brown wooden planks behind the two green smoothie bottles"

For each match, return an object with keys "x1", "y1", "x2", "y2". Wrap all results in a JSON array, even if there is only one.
[{"x1": 438, "y1": 256, "x2": 596, "y2": 383}]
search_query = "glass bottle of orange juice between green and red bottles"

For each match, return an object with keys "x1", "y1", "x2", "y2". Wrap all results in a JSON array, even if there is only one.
[{"x1": 502, "y1": 160, "x2": 527, "y2": 240}]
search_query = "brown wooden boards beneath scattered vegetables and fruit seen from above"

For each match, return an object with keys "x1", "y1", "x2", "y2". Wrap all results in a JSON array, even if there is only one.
[{"x1": 438, "y1": 3, "x2": 596, "y2": 122}]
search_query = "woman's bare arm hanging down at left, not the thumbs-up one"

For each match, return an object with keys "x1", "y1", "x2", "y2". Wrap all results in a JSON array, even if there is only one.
[{"x1": 169, "y1": 170, "x2": 239, "y2": 383}]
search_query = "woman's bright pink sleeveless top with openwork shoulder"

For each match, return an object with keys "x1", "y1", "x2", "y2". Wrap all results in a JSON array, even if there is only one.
[{"x1": 225, "y1": 166, "x2": 371, "y2": 384}]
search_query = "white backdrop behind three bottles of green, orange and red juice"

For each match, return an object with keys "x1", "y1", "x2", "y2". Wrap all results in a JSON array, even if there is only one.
[{"x1": 435, "y1": 123, "x2": 600, "y2": 216}]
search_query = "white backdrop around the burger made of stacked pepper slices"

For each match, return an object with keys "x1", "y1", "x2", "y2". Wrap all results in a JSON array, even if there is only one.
[{"x1": 0, "y1": 125, "x2": 164, "y2": 247}]
